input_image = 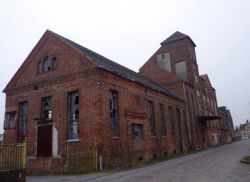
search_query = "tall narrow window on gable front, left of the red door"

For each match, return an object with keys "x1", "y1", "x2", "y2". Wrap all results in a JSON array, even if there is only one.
[{"x1": 19, "y1": 102, "x2": 28, "y2": 133}]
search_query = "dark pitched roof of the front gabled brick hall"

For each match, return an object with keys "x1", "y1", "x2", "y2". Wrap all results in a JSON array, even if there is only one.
[{"x1": 48, "y1": 30, "x2": 182, "y2": 100}]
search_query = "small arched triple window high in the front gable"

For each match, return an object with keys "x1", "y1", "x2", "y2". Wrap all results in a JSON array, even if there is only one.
[{"x1": 37, "y1": 56, "x2": 56, "y2": 73}]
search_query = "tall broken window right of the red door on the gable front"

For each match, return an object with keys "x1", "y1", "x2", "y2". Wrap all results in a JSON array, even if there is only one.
[{"x1": 69, "y1": 91, "x2": 79, "y2": 139}]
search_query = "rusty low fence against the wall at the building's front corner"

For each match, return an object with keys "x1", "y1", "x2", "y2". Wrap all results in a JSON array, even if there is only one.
[{"x1": 67, "y1": 142, "x2": 97, "y2": 172}]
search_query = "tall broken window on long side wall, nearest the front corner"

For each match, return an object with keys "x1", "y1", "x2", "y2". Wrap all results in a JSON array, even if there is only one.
[{"x1": 109, "y1": 90, "x2": 120, "y2": 137}]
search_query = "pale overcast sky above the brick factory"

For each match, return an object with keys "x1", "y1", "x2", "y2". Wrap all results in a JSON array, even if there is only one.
[{"x1": 0, "y1": 0, "x2": 250, "y2": 133}]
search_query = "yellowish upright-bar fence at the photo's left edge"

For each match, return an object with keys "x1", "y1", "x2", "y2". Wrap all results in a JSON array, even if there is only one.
[{"x1": 0, "y1": 143, "x2": 26, "y2": 170}]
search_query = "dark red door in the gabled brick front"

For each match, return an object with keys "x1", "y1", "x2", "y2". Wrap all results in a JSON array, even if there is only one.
[{"x1": 37, "y1": 125, "x2": 52, "y2": 157}]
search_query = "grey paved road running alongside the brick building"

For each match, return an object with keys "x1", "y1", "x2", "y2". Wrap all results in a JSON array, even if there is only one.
[{"x1": 27, "y1": 140, "x2": 250, "y2": 182}]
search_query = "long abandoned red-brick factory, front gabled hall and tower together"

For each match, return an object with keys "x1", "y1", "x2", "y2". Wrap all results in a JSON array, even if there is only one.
[{"x1": 1, "y1": 31, "x2": 228, "y2": 173}]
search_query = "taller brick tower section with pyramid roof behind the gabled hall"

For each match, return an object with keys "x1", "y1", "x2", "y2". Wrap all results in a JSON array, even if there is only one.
[{"x1": 139, "y1": 31, "x2": 219, "y2": 148}]
